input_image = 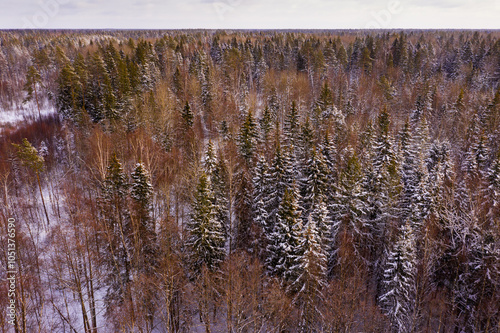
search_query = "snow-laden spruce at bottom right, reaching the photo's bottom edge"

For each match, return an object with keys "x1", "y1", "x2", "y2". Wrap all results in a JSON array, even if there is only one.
[{"x1": 379, "y1": 222, "x2": 417, "y2": 333}]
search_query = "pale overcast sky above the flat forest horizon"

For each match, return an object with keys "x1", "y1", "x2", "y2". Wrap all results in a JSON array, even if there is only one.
[{"x1": 0, "y1": 0, "x2": 500, "y2": 29}]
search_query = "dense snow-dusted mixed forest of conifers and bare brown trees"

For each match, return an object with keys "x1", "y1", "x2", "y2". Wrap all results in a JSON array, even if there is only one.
[{"x1": 0, "y1": 30, "x2": 500, "y2": 333}]
